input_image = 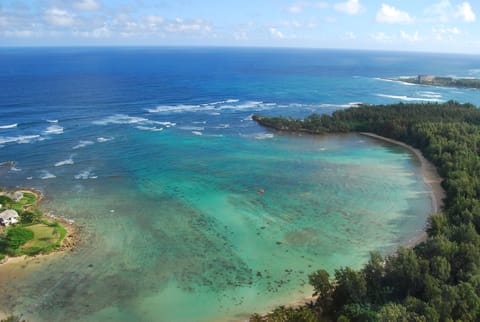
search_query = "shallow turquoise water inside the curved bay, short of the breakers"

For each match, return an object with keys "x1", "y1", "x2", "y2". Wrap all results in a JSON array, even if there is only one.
[{"x1": 0, "y1": 134, "x2": 431, "y2": 321}]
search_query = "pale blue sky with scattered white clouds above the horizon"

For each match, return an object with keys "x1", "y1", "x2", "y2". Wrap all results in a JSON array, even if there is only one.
[{"x1": 0, "y1": 0, "x2": 480, "y2": 54}]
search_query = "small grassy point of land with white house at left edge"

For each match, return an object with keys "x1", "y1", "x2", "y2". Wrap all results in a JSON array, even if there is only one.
[{"x1": 0, "y1": 189, "x2": 76, "y2": 263}]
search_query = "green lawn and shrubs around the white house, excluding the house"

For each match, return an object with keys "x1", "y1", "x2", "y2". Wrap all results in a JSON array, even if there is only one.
[{"x1": 0, "y1": 192, "x2": 67, "y2": 260}]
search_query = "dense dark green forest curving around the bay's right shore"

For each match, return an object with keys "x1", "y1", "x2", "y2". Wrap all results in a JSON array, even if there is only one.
[{"x1": 251, "y1": 101, "x2": 480, "y2": 322}]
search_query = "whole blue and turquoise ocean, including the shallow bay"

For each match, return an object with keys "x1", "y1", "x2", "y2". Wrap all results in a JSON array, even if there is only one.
[{"x1": 0, "y1": 48, "x2": 480, "y2": 321}]
